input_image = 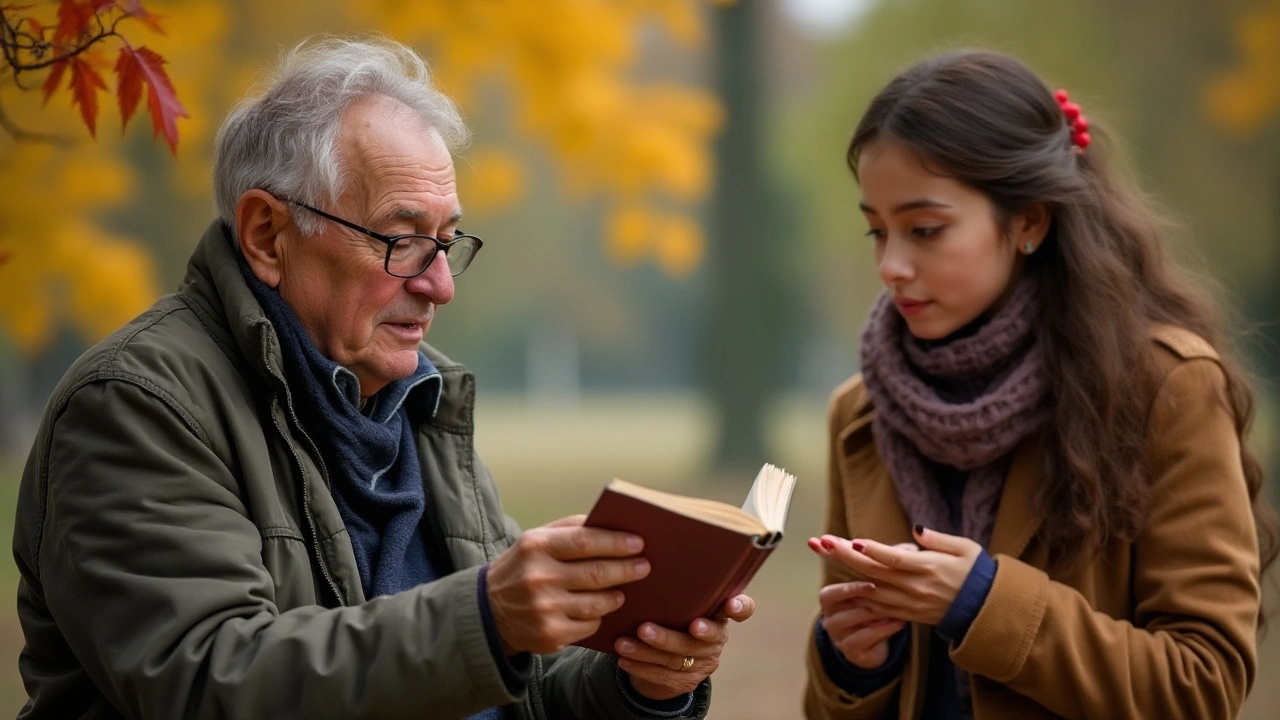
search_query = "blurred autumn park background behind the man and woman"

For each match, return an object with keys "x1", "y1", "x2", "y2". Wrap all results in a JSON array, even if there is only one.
[{"x1": 0, "y1": 0, "x2": 1280, "y2": 719}]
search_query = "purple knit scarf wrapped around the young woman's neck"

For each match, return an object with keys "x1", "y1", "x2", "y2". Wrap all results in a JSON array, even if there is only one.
[{"x1": 861, "y1": 274, "x2": 1047, "y2": 547}]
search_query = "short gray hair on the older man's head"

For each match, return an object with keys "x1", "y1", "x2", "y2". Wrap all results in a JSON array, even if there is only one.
[{"x1": 214, "y1": 37, "x2": 468, "y2": 234}]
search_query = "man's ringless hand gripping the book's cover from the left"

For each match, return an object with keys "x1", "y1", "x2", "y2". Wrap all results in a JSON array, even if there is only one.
[{"x1": 488, "y1": 515, "x2": 649, "y2": 656}]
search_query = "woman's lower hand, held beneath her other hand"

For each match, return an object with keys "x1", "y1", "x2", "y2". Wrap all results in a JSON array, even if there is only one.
[{"x1": 809, "y1": 538, "x2": 919, "y2": 670}]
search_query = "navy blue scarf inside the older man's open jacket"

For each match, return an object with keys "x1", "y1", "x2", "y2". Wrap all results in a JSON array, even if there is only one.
[{"x1": 237, "y1": 252, "x2": 442, "y2": 598}]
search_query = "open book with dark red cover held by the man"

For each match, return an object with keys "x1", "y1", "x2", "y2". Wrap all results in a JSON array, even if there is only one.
[{"x1": 577, "y1": 464, "x2": 796, "y2": 653}]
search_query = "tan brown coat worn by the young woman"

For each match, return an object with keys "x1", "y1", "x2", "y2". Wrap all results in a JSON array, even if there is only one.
[{"x1": 804, "y1": 328, "x2": 1261, "y2": 720}]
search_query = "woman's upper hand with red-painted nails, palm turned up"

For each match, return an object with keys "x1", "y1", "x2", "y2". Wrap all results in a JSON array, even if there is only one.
[{"x1": 819, "y1": 529, "x2": 982, "y2": 625}]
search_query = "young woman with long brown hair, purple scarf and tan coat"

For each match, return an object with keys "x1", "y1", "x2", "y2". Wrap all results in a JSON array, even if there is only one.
[{"x1": 805, "y1": 53, "x2": 1276, "y2": 720}]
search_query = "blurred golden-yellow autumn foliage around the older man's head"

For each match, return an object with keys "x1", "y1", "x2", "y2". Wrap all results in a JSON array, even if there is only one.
[{"x1": 0, "y1": 0, "x2": 742, "y2": 453}]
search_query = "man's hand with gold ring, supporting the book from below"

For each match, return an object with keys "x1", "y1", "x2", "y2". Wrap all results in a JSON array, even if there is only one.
[{"x1": 613, "y1": 594, "x2": 755, "y2": 700}]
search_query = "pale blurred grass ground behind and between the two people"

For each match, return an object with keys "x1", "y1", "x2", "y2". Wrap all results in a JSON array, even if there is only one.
[{"x1": 0, "y1": 396, "x2": 1280, "y2": 720}]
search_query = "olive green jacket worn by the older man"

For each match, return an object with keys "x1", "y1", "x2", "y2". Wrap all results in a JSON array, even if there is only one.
[{"x1": 14, "y1": 222, "x2": 710, "y2": 720}]
